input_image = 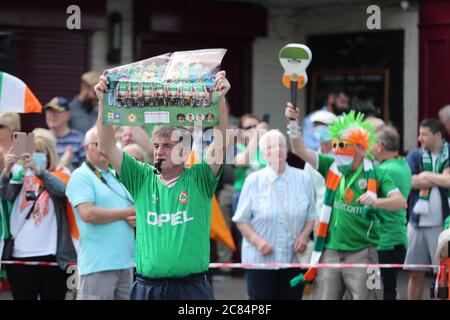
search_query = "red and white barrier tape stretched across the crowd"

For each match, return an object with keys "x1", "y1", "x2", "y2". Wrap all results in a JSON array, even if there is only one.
[{"x1": 0, "y1": 261, "x2": 440, "y2": 269}]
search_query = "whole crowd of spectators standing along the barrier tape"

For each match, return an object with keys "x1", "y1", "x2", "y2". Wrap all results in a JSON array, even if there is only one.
[{"x1": 0, "y1": 71, "x2": 450, "y2": 300}]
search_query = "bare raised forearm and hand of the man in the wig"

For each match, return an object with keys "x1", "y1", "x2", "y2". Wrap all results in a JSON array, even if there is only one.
[{"x1": 284, "y1": 102, "x2": 317, "y2": 168}]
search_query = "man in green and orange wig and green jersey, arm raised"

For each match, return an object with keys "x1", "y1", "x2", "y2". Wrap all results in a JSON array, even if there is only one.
[{"x1": 285, "y1": 103, "x2": 406, "y2": 300}]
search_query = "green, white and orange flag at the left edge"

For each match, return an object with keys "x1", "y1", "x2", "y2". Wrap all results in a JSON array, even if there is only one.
[{"x1": 0, "y1": 71, "x2": 42, "y2": 113}]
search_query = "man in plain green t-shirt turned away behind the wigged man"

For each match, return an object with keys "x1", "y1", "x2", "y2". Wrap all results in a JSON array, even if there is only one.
[{"x1": 372, "y1": 126, "x2": 412, "y2": 300}]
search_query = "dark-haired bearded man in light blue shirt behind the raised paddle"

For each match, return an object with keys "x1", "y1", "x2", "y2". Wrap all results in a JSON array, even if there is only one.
[{"x1": 302, "y1": 89, "x2": 349, "y2": 151}]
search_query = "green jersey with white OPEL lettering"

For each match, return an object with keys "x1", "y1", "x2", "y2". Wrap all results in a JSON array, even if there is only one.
[{"x1": 120, "y1": 153, "x2": 222, "y2": 278}]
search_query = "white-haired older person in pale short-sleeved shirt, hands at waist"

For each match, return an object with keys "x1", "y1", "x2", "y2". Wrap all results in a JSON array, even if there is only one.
[{"x1": 233, "y1": 130, "x2": 317, "y2": 300}]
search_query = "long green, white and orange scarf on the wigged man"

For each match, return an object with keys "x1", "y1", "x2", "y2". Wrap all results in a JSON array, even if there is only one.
[{"x1": 291, "y1": 158, "x2": 377, "y2": 287}]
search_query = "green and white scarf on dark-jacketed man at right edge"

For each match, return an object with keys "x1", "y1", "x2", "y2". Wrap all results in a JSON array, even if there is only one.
[{"x1": 413, "y1": 142, "x2": 450, "y2": 215}]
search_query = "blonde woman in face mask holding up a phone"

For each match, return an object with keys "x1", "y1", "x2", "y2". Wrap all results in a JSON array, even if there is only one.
[{"x1": 0, "y1": 129, "x2": 76, "y2": 300}]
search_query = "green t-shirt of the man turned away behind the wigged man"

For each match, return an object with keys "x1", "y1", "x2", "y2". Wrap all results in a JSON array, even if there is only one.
[{"x1": 378, "y1": 157, "x2": 412, "y2": 250}]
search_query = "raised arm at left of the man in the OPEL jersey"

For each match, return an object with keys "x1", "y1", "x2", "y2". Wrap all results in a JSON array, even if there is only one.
[{"x1": 94, "y1": 75, "x2": 123, "y2": 175}]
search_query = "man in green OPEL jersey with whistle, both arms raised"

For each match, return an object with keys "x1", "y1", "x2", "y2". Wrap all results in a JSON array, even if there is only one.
[{"x1": 95, "y1": 71, "x2": 230, "y2": 299}]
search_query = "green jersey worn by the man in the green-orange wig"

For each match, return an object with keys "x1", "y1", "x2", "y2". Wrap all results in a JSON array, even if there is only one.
[{"x1": 318, "y1": 154, "x2": 397, "y2": 251}]
